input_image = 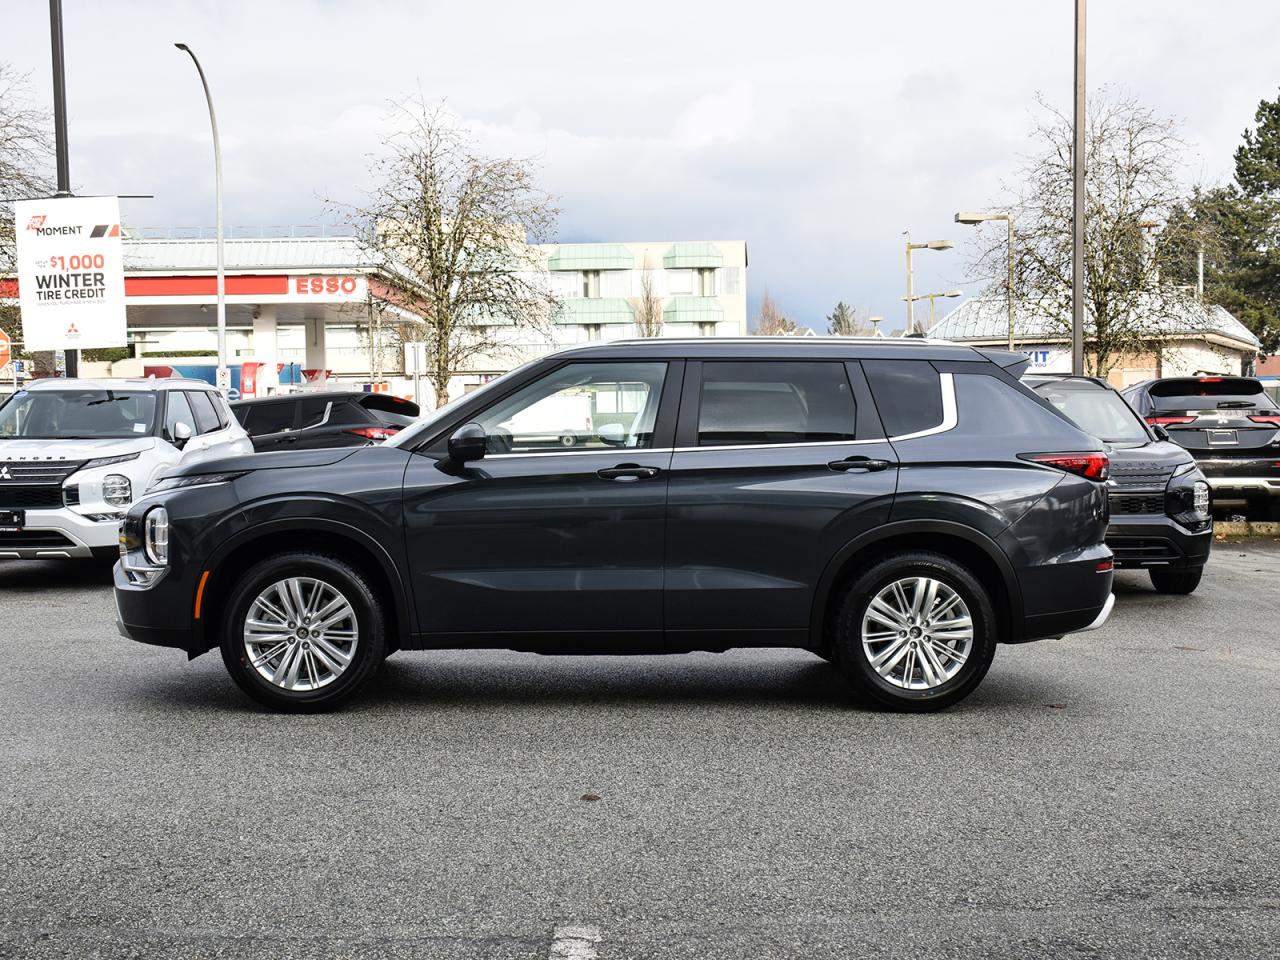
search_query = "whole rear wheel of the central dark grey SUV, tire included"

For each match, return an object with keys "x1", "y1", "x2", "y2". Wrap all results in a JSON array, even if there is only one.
[{"x1": 833, "y1": 552, "x2": 996, "y2": 712}]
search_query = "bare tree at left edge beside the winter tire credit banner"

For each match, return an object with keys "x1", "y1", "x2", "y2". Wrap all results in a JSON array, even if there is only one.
[{"x1": 0, "y1": 63, "x2": 54, "y2": 353}]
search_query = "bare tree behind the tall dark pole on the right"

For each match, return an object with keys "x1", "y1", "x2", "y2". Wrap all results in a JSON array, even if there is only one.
[{"x1": 975, "y1": 88, "x2": 1190, "y2": 375}]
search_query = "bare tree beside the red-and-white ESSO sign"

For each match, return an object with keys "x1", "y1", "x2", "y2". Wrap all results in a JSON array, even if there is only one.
[{"x1": 334, "y1": 99, "x2": 558, "y2": 406}]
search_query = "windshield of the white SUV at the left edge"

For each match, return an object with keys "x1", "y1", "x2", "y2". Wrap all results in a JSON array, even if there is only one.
[{"x1": 0, "y1": 390, "x2": 156, "y2": 440}]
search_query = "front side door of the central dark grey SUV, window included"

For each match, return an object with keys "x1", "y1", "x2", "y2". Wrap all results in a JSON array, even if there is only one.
[{"x1": 404, "y1": 361, "x2": 682, "y2": 648}]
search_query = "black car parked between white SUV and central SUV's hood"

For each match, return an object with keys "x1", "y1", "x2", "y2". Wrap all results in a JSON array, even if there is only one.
[{"x1": 232, "y1": 390, "x2": 419, "y2": 451}]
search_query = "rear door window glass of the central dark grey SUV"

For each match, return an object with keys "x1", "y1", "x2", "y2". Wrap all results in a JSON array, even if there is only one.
[{"x1": 698, "y1": 360, "x2": 858, "y2": 447}]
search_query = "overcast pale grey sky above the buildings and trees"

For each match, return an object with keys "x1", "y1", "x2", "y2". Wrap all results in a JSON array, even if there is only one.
[{"x1": 0, "y1": 0, "x2": 1280, "y2": 328}]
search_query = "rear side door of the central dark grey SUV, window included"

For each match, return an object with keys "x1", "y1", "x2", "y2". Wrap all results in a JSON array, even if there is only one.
[{"x1": 664, "y1": 360, "x2": 897, "y2": 645}]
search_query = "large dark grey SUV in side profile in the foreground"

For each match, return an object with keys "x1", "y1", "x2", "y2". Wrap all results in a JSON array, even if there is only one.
[{"x1": 115, "y1": 338, "x2": 1112, "y2": 710}]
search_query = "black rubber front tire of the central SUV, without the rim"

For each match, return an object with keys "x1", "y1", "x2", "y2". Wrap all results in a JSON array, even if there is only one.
[{"x1": 220, "y1": 552, "x2": 387, "y2": 713}]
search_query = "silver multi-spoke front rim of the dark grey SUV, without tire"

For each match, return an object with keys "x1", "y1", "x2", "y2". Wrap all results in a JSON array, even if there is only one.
[{"x1": 244, "y1": 577, "x2": 360, "y2": 692}]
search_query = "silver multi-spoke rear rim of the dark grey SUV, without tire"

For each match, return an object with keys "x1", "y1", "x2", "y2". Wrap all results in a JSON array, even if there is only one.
[{"x1": 861, "y1": 577, "x2": 973, "y2": 690}]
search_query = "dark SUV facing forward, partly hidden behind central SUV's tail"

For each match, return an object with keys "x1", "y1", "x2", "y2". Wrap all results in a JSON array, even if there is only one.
[{"x1": 1023, "y1": 375, "x2": 1213, "y2": 594}]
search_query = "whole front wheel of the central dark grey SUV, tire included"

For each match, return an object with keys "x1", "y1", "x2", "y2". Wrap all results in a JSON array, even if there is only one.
[{"x1": 221, "y1": 553, "x2": 385, "y2": 712}]
